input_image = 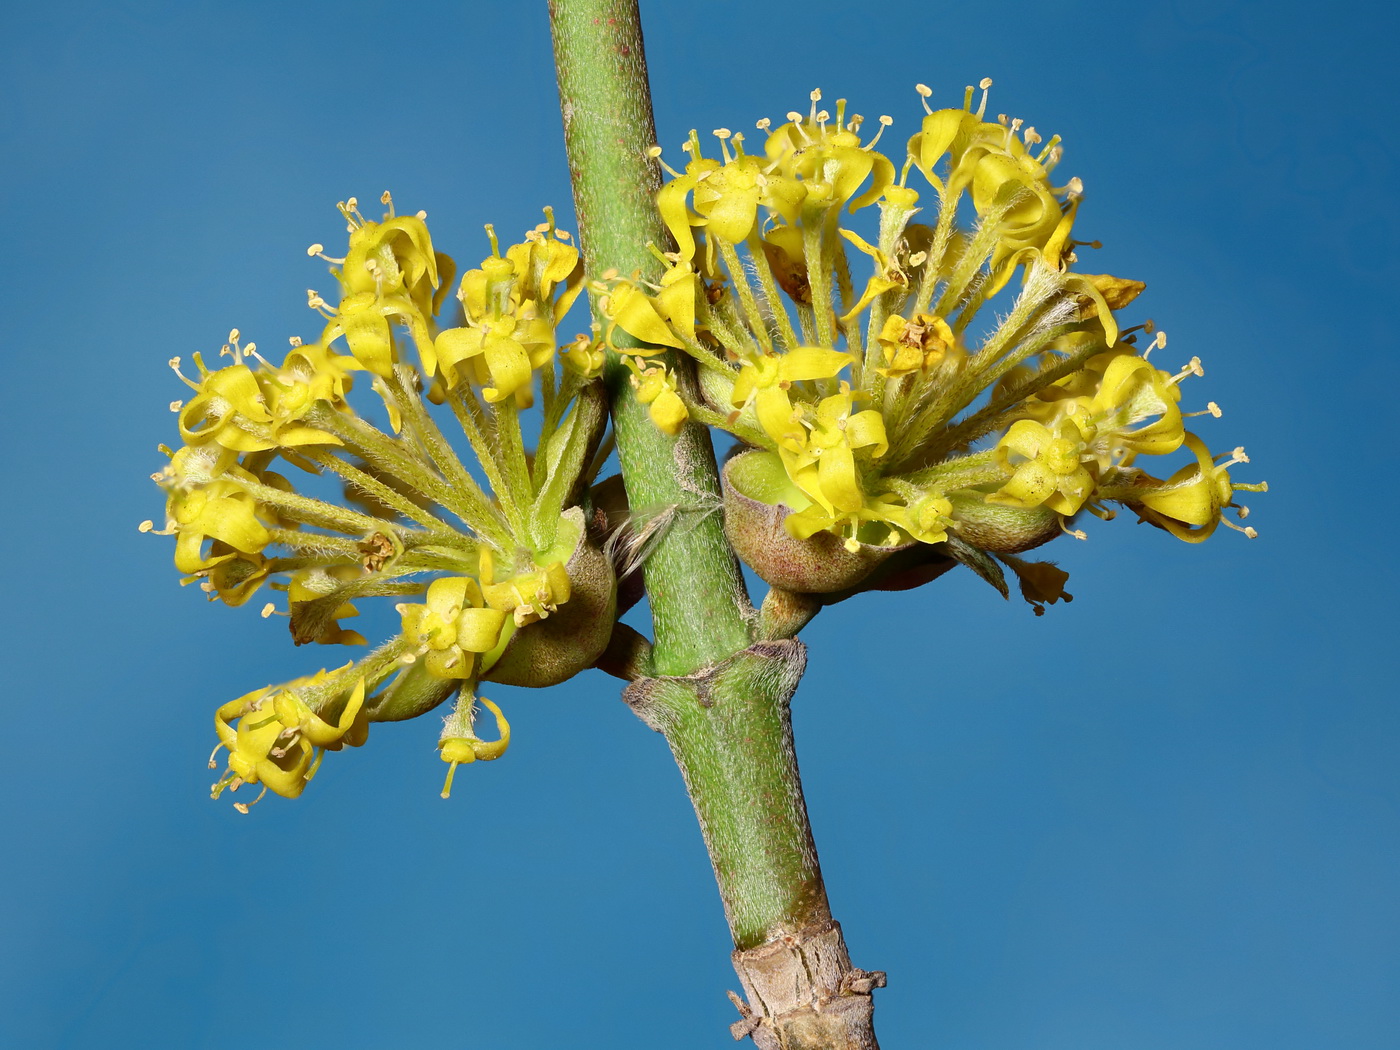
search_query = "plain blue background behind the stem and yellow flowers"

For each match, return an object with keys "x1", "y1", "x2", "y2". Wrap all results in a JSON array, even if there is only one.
[{"x1": 0, "y1": 0, "x2": 1400, "y2": 1050}]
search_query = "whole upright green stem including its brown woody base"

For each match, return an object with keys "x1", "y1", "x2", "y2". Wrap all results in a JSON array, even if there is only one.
[{"x1": 549, "y1": 0, "x2": 883, "y2": 1050}]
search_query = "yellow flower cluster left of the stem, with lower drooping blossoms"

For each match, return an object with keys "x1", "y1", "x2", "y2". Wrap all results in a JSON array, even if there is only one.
[{"x1": 143, "y1": 193, "x2": 616, "y2": 812}]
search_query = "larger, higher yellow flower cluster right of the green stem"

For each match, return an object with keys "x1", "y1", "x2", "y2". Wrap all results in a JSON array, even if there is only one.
[{"x1": 605, "y1": 81, "x2": 1264, "y2": 610}]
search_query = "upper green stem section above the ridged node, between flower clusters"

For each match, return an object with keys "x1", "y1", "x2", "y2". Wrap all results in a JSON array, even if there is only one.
[{"x1": 550, "y1": 0, "x2": 749, "y2": 675}]
